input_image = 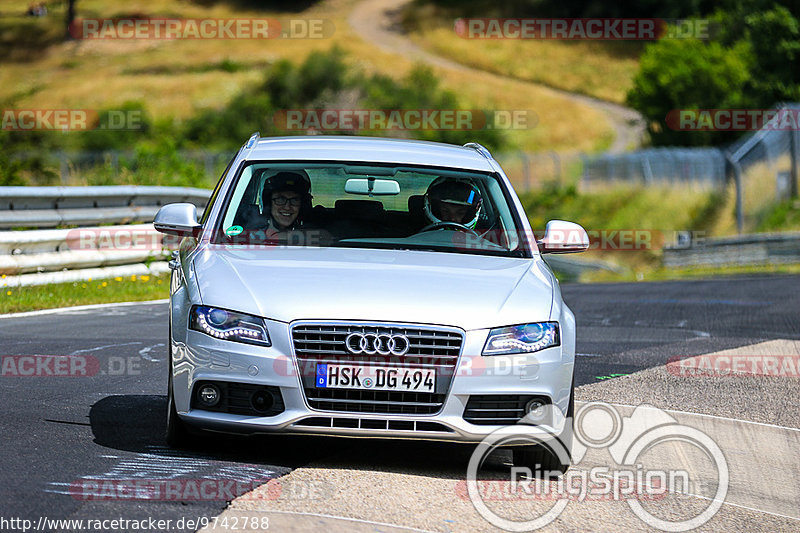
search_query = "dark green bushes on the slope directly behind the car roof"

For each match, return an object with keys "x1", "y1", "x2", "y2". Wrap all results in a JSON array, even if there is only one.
[{"x1": 182, "y1": 48, "x2": 505, "y2": 149}]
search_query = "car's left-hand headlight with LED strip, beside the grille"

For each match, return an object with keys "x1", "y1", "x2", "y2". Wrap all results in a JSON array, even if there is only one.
[{"x1": 189, "y1": 305, "x2": 272, "y2": 346}]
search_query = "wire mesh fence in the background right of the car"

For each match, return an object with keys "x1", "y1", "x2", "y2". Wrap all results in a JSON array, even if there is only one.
[{"x1": 498, "y1": 103, "x2": 800, "y2": 233}]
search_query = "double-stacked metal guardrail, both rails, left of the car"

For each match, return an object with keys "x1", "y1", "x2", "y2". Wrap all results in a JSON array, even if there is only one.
[{"x1": 0, "y1": 186, "x2": 211, "y2": 287}]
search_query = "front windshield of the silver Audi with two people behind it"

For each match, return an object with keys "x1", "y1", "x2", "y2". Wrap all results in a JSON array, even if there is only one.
[{"x1": 212, "y1": 162, "x2": 526, "y2": 257}]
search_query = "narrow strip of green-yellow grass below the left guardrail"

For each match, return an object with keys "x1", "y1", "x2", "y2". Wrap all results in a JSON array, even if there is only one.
[{"x1": 0, "y1": 274, "x2": 169, "y2": 313}]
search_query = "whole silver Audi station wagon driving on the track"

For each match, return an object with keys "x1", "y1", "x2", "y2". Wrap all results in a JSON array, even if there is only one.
[{"x1": 154, "y1": 134, "x2": 588, "y2": 468}]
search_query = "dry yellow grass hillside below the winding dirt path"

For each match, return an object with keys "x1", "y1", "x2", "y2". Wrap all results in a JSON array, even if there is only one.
[{"x1": 0, "y1": 0, "x2": 613, "y2": 155}]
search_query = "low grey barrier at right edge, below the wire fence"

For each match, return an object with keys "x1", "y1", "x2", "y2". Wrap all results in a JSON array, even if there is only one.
[{"x1": 664, "y1": 232, "x2": 800, "y2": 268}]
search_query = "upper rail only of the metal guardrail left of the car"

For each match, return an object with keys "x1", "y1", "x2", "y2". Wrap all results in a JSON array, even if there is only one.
[{"x1": 0, "y1": 185, "x2": 211, "y2": 228}]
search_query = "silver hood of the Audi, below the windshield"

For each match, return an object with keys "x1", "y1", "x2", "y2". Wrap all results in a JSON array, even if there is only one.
[{"x1": 193, "y1": 247, "x2": 554, "y2": 330}]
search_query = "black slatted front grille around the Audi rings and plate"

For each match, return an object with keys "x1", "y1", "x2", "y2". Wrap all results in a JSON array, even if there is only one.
[{"x1": 292, "y1": 323, "x2": 464, "y2": 415}]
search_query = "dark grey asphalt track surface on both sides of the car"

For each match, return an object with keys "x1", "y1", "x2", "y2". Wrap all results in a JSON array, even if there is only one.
[{"x1": 0, "y1": 276, "x2": 800, "y2": 530}]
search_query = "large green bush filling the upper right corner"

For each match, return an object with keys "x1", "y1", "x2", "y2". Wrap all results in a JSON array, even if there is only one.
[{"x1": 627, "y1": 0, "x2": 800, "y2": 145}]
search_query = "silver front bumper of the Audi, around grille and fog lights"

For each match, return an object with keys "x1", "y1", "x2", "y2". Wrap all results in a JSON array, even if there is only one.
[{"x1": 170, "y1": 321, "x2": 574, "y2": 443}]
